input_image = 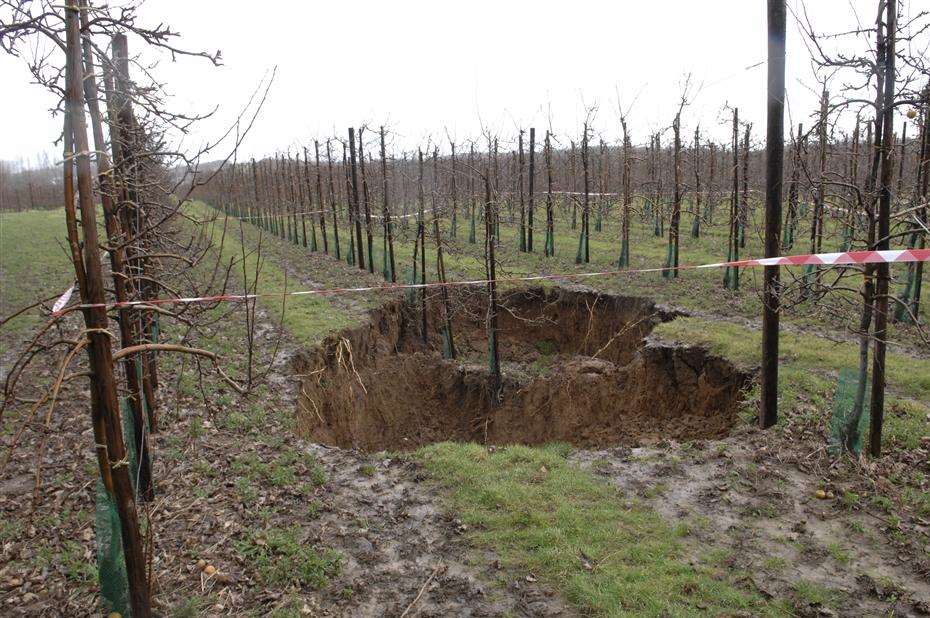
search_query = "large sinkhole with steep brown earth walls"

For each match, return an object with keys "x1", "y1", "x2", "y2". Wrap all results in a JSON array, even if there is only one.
[{"x1": 293, "y1": 288, "x2": 750, "y2": 451}]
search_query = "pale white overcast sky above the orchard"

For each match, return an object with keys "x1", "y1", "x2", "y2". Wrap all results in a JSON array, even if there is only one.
[{"x1": 0, "y1": 0, "x2": 920, "y2": 165}]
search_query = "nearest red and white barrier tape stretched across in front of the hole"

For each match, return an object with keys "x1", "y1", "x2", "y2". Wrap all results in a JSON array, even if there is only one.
[{"x1": 52, "y1": 249, "x2": 930, "y2": 315}]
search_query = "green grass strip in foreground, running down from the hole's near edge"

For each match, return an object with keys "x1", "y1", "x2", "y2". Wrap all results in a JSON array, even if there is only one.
[{"x1": 416, "y1": 443, "x2": 777, "y2": 616}]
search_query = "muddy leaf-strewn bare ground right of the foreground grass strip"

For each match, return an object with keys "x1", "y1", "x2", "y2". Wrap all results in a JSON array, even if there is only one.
[{"x1": 573, "y1": 428, "x2": 930, "y2": 616}]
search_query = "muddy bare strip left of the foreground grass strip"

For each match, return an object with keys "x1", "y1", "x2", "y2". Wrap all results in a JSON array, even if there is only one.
[{"x1": 298, "y1": 445, "x2": 575, "y2": 617}]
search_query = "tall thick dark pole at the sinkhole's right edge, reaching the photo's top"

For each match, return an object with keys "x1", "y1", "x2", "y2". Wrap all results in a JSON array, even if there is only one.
[{"x1": 759, "y1": 0, "x2": 785, "y2": 429}]
